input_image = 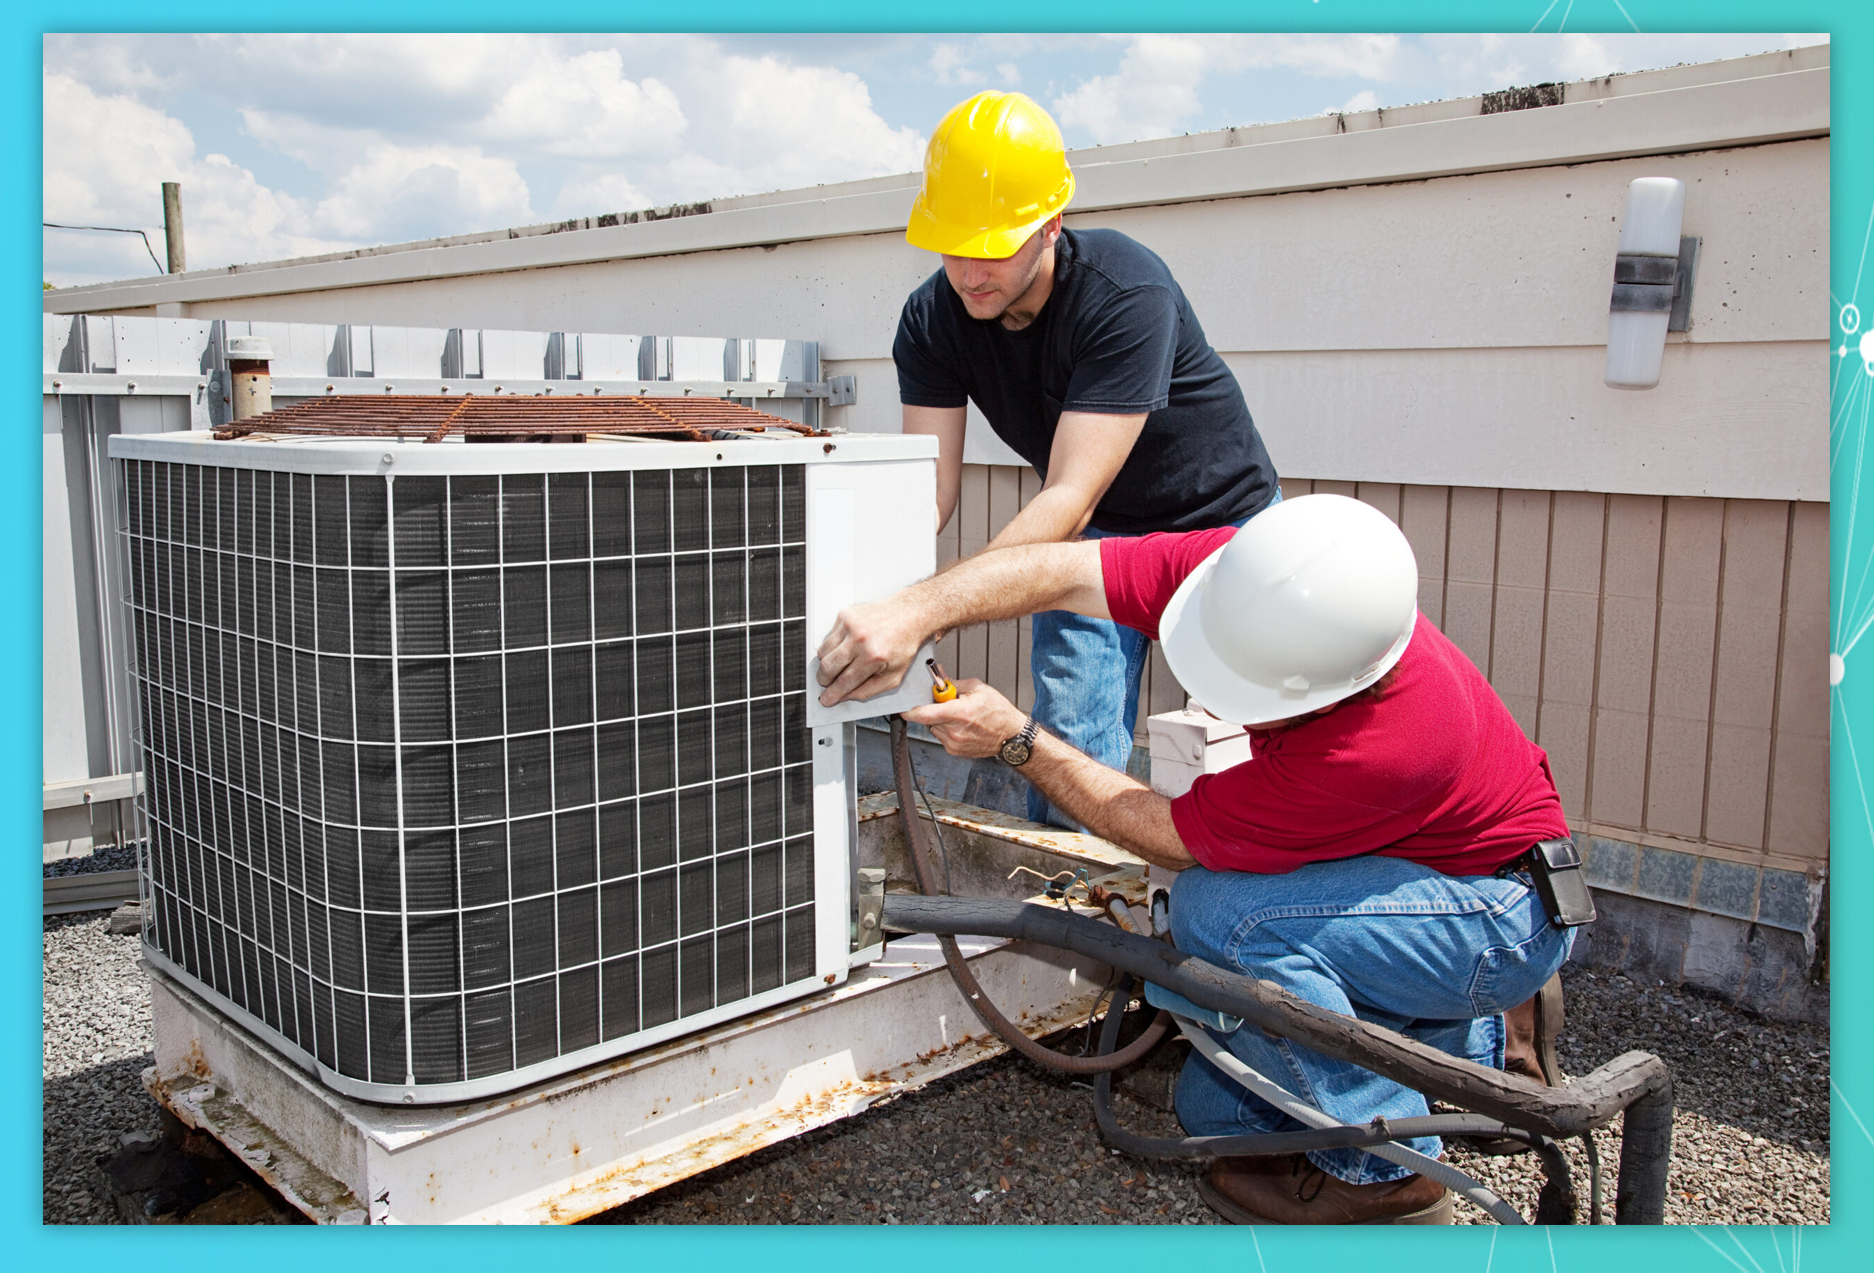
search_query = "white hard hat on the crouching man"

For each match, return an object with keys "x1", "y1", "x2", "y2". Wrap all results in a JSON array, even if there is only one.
[{"x1": 1158, "y1": 495, "x2": 1419, "y2": 726}]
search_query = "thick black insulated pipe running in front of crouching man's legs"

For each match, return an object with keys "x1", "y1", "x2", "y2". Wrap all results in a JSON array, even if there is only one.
[{"x1": 883, "y1": 894, "x2": 1672, "y2": 1139}]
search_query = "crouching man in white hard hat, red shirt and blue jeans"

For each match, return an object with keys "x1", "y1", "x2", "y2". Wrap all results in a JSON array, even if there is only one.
[{"x1": 819, "y1": 495, "x2": 1572, "y2": 1224}]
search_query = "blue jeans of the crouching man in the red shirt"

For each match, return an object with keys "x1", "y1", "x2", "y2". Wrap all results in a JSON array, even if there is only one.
[{"x1": 1171, "y1": 855, "x2": 1574, "y2": 1185}]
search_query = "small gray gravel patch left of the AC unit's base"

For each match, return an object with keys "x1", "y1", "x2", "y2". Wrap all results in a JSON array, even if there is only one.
[{"x1": 43, "y1": 911, "x2": 157, "y2": 1224}]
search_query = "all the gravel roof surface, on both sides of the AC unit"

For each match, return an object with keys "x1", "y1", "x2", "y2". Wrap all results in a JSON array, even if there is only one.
[{"x1": 45, "y1": 913, "x2": 1829, "y2": 1224}]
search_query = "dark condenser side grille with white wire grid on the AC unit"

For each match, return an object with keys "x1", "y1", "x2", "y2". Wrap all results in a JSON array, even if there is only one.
[{"x1": 118, "y1": 459, "x2": 813, "y2": 1086}]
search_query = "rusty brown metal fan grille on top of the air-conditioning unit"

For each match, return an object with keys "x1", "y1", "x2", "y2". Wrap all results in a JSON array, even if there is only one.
[{"x1": 216, "y1": 394, "x2": 817, "y2": 442}]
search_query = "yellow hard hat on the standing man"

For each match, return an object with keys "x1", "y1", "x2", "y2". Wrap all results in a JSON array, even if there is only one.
[{"x1": 905, "y1": 92, "x2": 1074, "y2": 259}]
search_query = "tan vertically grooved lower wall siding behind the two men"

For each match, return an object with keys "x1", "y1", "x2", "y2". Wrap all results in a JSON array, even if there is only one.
[{"x1": 939, "y1": 465, "x2": 1829, "y2": 868}]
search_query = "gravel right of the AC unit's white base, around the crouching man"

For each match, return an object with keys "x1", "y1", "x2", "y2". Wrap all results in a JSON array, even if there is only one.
[{"x1": 598, "y1": 969, "x2": 1829, "y2": 1224}]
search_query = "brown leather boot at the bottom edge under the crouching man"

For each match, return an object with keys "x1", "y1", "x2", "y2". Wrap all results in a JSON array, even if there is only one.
[{"x1": 1197, "y1": 1153, "x2": 1450, "y2": 1224}]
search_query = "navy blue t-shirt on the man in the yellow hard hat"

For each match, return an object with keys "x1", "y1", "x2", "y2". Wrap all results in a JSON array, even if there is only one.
[{"x1": 892, "y1": 231, "x2": 1276, "y2": 534}]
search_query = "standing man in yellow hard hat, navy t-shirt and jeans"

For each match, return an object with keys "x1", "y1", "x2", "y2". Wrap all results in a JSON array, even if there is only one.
[{"x1": 892, "y1": 92, "x2": 1282, "y2": 827}]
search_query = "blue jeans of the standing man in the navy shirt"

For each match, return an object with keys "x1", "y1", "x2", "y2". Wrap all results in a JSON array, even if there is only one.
[{"x1": 1029, "y1": 487, "x2": 1282, "y2": 831}]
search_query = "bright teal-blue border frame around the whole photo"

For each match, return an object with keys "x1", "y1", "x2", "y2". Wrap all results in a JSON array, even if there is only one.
[{"x1": 0, "y1": 0, "x2": 1874, "y2": 1273}]
